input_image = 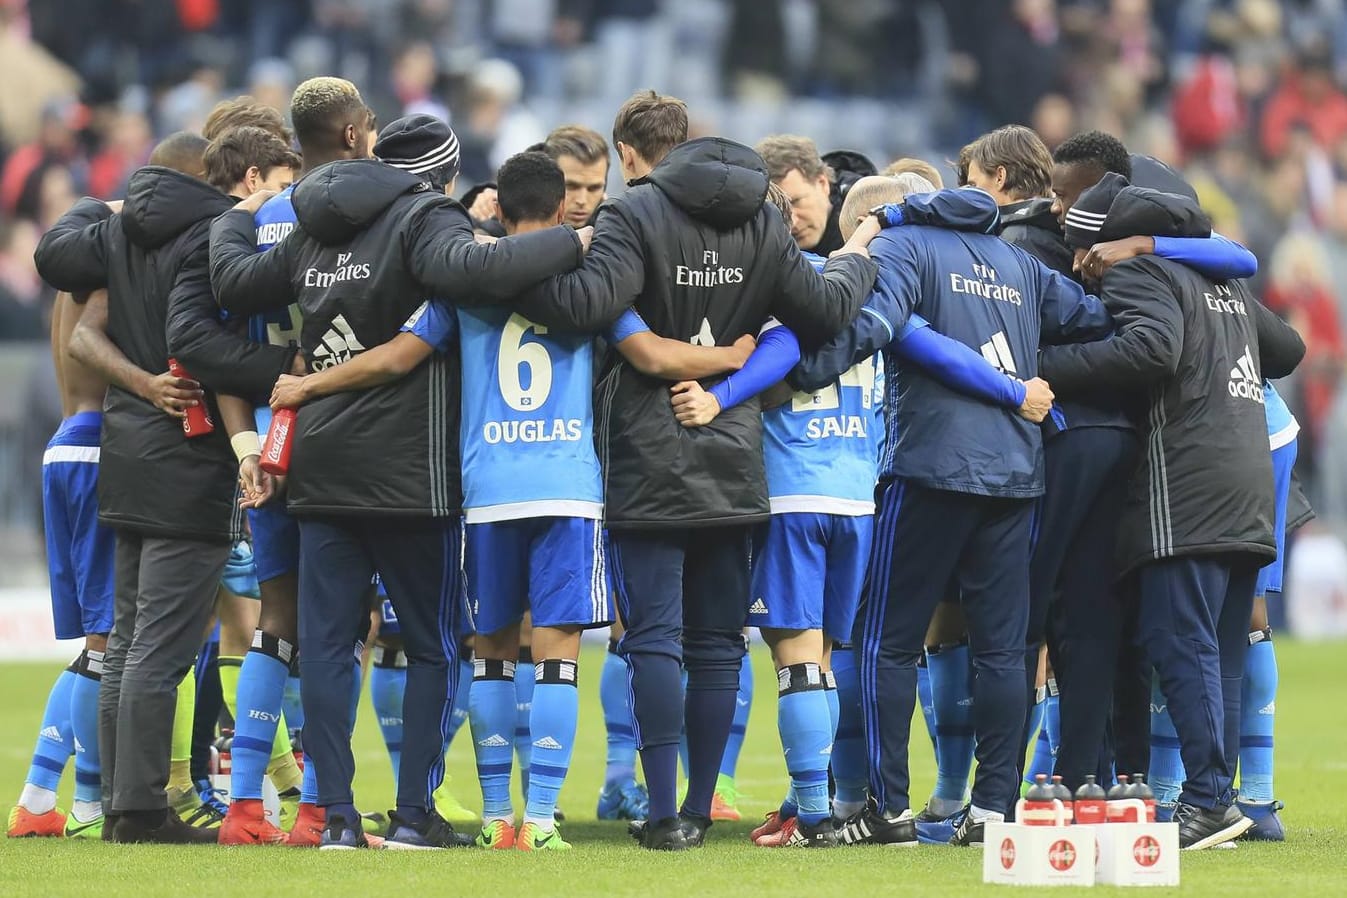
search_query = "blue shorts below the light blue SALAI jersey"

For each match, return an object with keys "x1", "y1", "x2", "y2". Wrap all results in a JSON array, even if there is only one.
[{"x1": 749, "y1": 512, "x2": 874, "y2": 642}]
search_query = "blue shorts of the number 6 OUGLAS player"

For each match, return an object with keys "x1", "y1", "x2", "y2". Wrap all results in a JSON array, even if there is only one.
[{"x1": 463, "y1": 517, "x2": 613, "y2": 633}]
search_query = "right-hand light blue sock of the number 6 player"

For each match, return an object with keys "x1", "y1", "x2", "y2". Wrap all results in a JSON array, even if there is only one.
[{"x1": 524, "y1": 658, "x2": 581, "y2": 829}]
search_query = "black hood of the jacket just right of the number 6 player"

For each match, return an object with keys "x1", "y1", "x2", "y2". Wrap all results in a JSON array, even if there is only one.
[{"x1": 643, "y1": 137, "x2": 768, "y2": 230}]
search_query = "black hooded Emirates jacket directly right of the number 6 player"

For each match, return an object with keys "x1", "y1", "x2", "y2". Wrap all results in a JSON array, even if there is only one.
[{"x1": 511, "y1": 137, "x2": 876, "y2": 528}]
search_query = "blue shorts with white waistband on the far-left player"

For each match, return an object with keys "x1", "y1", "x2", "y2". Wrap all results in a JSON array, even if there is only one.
[{"x1": 42, "y1": 412, "x2": 114, "y2": 640}]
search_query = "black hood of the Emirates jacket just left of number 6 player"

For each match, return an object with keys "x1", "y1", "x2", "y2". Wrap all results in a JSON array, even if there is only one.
[{"x1": 292, "y1": 159, "x2": 431, "y2": 246}]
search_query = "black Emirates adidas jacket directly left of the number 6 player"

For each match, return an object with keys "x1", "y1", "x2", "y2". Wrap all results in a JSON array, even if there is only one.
[{"x1": 210, "y1": 160, "x2": 581, "y2": 517}]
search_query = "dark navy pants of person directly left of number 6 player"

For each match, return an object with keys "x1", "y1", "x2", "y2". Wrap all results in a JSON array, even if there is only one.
[{"x1": 299, "y1": 517, "x2": 465, "y2": 809}]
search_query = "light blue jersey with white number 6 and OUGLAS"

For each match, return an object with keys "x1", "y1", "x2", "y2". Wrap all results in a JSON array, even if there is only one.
[{"x1": 398, "y1": 303, "x2": 603, "y2": 524}]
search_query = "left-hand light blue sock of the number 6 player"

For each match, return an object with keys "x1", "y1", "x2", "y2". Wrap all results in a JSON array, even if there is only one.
[{"x1": 467, "y1": 658, "x2": 516, "y2": 825}]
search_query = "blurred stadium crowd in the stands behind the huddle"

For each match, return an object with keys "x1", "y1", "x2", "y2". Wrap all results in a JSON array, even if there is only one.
[{"x1": 0, "y1": 0, "x2": 1347, "y2": 562}]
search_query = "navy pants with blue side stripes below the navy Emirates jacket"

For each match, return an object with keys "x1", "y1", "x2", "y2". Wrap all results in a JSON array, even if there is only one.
[{"x1": 854, "y1": 481, "x2": 1033, "y2": 815}]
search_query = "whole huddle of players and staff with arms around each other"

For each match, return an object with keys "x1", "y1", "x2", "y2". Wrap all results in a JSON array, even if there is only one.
[{"x1": 9, "y1": 72, "x2": 1304, "y2": 851}]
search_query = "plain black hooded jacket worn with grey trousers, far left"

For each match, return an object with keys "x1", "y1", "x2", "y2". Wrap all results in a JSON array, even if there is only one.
[{"x1": 35, "y1": 166, "x2": 270, "y2": 541}]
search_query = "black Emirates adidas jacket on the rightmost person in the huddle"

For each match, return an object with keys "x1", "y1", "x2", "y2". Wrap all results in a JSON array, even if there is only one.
[{"x1": 1040, "y1": 187, "x2": 1305, "y2": 574}]
